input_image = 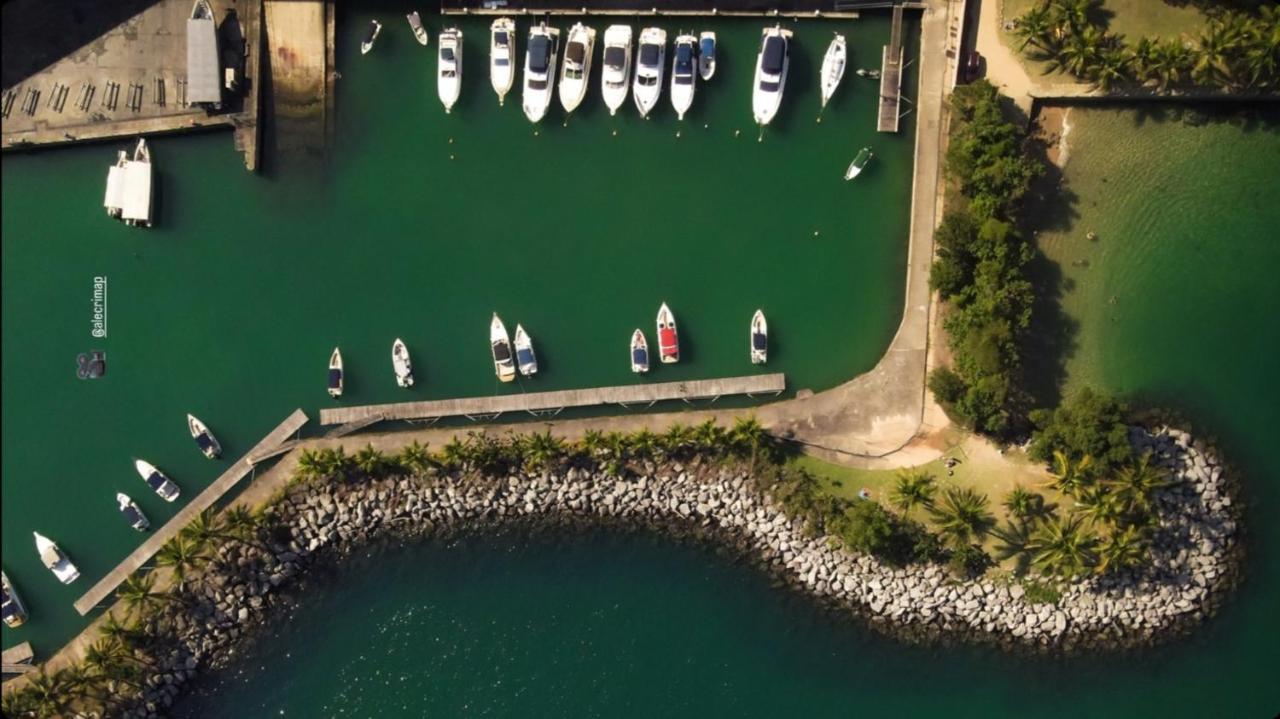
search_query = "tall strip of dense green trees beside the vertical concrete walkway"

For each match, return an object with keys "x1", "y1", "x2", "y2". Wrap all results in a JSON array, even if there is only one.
[{"x1": 929, "y1": 81, "x2": 1042, "y2": 438}]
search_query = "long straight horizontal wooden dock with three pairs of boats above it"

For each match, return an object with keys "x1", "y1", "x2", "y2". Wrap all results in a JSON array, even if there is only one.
[{"x1": 320, "y1": 372, "x2": 786, "y2": 426}]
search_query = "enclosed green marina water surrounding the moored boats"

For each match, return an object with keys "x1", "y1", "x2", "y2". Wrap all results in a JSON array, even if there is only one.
[{"x1": 3, "y1": 9, "x2": 914, "y2": 655}]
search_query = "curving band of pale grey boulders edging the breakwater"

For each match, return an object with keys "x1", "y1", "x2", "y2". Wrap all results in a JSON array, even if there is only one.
[{"x1": 128, "y1": 429, "x2": 1242, "y2": 716}]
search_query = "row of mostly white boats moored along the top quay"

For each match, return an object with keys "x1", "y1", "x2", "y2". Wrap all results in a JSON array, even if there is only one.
[{"x1": 361, "y1": 13, "x2": 849, "y2": 125}]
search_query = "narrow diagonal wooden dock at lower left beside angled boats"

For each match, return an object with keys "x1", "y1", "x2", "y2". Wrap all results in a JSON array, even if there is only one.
[{"x1": 76, "y1": 409, "x2": 307, "y2": 615}]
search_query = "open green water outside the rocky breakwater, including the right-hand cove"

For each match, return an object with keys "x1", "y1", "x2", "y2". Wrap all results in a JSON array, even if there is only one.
[{"x1": 170, "y1": 110, "x2": 1280, "y2": 718}]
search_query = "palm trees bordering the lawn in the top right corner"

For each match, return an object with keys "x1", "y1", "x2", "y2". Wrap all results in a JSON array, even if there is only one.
[{"x1": 1014, "y1": 0, "x2": 1280, "y2": 92}]
